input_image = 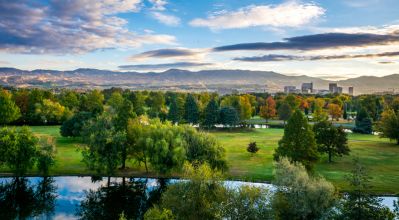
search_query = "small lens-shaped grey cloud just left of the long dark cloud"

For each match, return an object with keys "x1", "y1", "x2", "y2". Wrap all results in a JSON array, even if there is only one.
[{"x1": 129, "y1": 48, "x2": 201, "y2": 60}]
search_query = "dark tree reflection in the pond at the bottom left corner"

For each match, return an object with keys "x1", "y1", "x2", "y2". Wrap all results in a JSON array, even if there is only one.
[{"x1": 0, "y1": 177, "x2": 57, "y2": 219}]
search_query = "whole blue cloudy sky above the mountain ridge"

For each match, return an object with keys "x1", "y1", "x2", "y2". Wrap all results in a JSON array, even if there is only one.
[{"x1": 0, "y1": 0, "x2": 399, "y2": 80}]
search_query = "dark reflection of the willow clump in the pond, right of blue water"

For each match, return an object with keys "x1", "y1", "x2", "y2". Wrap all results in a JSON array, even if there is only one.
[{"x1": 77, "y1": 178, "x2": 167, "y2": 220}]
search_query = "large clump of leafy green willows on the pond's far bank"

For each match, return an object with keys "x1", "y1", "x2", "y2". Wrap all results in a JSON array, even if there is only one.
[{"x1": 72, "y1": 93, "x2": 227, "y2": 175}]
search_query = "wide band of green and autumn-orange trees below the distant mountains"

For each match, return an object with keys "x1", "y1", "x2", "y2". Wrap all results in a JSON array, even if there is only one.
[{"x1": 0, "y1": 88, "x2": 399, "y2": 139}]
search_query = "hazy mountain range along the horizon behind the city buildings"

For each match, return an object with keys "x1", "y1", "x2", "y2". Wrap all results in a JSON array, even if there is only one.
[{"x1": 0, "y1": 68, "x2": 399, "y2": 94}]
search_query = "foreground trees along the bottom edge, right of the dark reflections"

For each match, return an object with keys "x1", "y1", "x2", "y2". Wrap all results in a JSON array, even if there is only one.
[{"x1": 144, "y1": 158, "x2": 395, "y2": 220}]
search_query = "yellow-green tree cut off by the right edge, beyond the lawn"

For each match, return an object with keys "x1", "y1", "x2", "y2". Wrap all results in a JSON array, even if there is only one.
[{"x1": 378, "y1": 109, "x2": 399, "y2": 145}]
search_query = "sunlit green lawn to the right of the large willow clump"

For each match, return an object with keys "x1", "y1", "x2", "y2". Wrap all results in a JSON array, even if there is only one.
[{"x1": 213, "y1": 129, "x2": 399, "y2": 194}]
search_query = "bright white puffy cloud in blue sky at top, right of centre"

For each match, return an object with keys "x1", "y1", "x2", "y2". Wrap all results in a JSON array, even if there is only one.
[{"x1": 190, "y1": 1, "x2": 325, "y2": 29}]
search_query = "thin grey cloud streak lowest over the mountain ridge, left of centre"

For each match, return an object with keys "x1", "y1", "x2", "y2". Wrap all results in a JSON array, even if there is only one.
[{"x1": 119, "y1": 62, "x2": 213, "y2": 70}]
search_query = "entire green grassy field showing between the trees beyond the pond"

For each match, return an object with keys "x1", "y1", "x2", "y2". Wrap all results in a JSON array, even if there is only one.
[{"x1": 1, "y1": 126, "x2": 399, "y2": 194}]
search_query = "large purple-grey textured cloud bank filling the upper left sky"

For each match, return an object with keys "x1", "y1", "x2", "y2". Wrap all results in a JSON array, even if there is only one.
[{"x1": 0, "y1": 0, "x2": 176, "y2": 54}]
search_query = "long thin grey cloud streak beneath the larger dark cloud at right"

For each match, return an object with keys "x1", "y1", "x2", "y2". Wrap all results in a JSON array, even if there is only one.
[{"x1": 233, "y1": 51, "x2": 399, "y2": 63}]
